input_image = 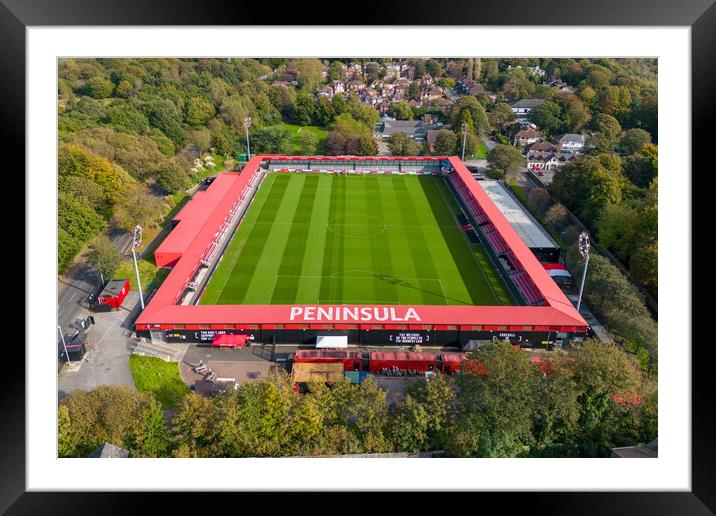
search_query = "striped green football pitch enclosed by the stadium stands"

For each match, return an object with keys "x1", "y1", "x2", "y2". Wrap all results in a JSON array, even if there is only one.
[{"x1": 200, "y1": 173, "x2": 516, "y2": 305}]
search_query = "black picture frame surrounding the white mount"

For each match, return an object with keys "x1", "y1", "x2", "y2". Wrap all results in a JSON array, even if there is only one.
[{"x1": 5, "y1": 0, "x2": 716, "y2": 514}]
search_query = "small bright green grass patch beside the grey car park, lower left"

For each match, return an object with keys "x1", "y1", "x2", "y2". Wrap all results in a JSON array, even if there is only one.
[{"x1": 129, "y1": 355, "x2": 189, "y2": 409}]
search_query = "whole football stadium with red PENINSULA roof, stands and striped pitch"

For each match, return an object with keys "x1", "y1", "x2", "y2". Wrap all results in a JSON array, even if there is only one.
[{"x1": 136, "y1": 155, "x2": 588, "y2": 349}]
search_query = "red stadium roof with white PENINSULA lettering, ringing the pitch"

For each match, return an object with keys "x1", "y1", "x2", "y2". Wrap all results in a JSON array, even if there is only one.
[{"x1": 136, "y1": 155, "x2": 588, "y2": 331}]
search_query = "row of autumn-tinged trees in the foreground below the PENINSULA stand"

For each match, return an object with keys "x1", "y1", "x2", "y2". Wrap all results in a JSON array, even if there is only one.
[{"x1": 58, "y1": 341, "x2": 658, "y2": 457}]
